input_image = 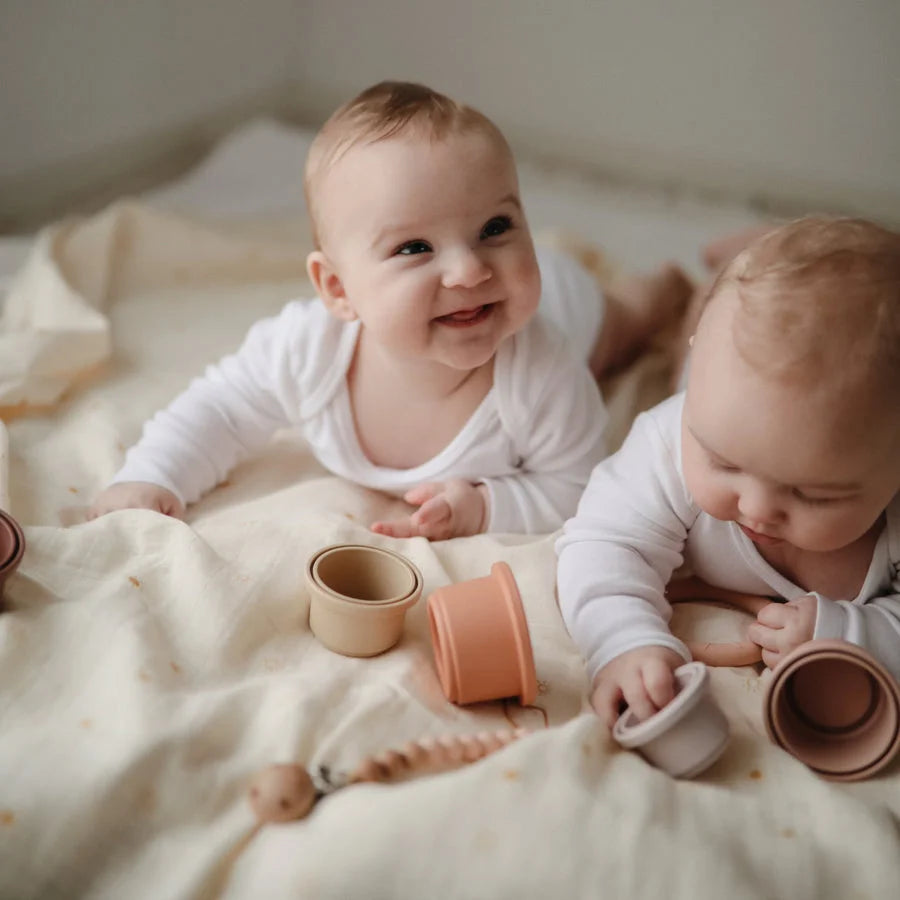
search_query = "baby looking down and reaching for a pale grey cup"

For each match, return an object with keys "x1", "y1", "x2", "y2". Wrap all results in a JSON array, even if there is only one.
[{"x1": 557, "y1": 218, "x2": 900, "y2": 724}]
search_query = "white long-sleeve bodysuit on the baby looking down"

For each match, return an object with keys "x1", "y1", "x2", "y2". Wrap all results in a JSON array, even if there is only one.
[{"x1": 556, "y1": 393, "x2": 900, "y2": 679}]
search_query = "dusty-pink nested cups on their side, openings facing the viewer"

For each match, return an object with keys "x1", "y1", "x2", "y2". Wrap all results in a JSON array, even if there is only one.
[{"x1": 763, "y1": 640, "x2": 900, "y2": 781}]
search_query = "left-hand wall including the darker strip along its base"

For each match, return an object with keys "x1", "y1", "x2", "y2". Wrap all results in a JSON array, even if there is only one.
[{"x1": 0, "y1": 0, "x2": 302, "y2": 228}]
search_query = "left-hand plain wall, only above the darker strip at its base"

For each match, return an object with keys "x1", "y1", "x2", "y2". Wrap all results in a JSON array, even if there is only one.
[{"x1": 0, "y1": 0, "x2": 296, "y2": 175}]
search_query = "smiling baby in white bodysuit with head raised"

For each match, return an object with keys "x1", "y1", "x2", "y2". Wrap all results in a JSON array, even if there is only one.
[{"x1": 91, "y1": 82, "x2": 674, "y2": 539}]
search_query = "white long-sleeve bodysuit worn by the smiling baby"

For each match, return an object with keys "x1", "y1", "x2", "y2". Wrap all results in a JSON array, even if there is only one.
[{"x1": 113, "y1": 251, "x2": 607, "y2": 533}]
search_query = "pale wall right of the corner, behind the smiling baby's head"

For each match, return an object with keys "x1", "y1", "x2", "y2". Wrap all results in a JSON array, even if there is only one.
[{"x1": 297, "y1": 0, "x2": 900, "y2": 221}]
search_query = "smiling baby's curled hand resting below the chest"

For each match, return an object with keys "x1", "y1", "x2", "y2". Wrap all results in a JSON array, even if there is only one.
[{"x1": 372, "y1": 478, "x2": 488, "y2": 541}]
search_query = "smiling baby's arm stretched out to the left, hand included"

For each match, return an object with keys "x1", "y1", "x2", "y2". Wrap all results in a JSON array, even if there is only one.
[{"x1": 89, "y1": 304, "x2": 299, "y2": 517}]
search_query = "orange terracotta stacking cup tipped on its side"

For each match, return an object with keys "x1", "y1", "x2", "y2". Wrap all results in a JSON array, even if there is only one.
[{"x1": 428, "y1": 562, "x2": 537, "y2": 706}]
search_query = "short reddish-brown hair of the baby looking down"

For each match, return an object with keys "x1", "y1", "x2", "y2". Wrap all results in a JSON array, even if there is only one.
[{"x1": 710, "y1": 216, "x2": 900, "y2": 390}]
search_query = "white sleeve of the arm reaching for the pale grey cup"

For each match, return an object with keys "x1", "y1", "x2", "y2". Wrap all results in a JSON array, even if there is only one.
[{"x1": 556, "y1": 397, "x2": 697, "y2": 679}]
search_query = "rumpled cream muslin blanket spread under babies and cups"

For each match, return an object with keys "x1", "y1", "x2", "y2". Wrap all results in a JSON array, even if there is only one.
[{"x1": 0, "y1": 204, "x2": 900, "y2": 900}]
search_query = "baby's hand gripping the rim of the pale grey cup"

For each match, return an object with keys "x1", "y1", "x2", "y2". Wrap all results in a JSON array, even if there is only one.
[{"x1": 591, "y1": 646, "x2": 684, "y2": 728}]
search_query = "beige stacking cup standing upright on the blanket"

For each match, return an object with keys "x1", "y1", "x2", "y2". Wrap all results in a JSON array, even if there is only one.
[{"x1": 306, "y1": 544, "x2": 422, "y2": 656}]
